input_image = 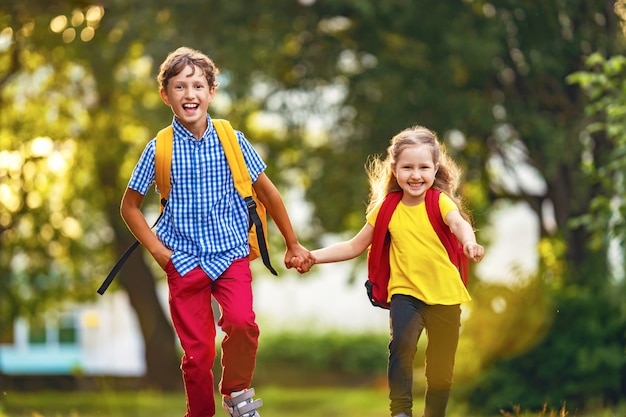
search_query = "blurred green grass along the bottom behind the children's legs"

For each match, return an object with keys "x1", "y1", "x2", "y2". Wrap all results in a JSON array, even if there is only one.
[{"x1": 0, "y1": 385, "x2": 626, "y2": 417}]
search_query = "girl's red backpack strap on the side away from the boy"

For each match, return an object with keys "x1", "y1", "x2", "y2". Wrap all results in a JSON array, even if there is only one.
[{"x1": 426, "y1": 188, "x2": 469, "y2": 287}]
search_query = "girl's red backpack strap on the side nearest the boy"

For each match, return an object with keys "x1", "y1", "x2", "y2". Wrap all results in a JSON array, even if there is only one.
[{"x1": 365, "y1": 191, "x2": 402, "y2": 308}]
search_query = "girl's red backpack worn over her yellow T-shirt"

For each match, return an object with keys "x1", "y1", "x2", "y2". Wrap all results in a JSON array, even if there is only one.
[{"x1": 365, "y1": 188, "x2": 469, "y2": 309}]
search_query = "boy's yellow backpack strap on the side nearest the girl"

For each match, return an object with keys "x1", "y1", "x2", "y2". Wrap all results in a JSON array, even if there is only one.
[{"x1": 213, "y1": 119, "x2": 278, "y2": 275}]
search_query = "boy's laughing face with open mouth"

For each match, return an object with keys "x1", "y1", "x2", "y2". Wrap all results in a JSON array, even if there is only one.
[{"x1": 161, "y1": 65, "x2": 215, "y2": 138}]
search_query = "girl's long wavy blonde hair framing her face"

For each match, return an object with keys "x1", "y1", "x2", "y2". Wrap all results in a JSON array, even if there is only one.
[{"x1": 366, "y1": 126, "x2": 470, "y2": 221}]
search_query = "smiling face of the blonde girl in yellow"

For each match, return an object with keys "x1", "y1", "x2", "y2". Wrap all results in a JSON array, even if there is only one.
[{"x1": 393, "y1": 145, "x2": 439, "y2": 206}]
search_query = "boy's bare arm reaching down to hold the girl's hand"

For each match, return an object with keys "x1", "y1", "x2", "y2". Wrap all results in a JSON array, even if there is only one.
[{"x1": 252, "y1": 172, "x2": 315, "y2": 272}]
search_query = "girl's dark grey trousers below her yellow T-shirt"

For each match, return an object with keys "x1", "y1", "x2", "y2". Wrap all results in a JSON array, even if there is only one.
[{"x1": 387, "y1": 294, "x2": 461, "y2": 416}]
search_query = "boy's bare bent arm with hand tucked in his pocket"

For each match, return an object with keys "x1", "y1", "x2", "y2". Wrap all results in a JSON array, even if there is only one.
[{"x1": 120, "y1": 188, "x2": 172, "y2": 269}]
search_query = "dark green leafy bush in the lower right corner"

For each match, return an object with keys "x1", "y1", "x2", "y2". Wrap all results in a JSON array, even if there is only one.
[{"x1": 468, "y1": 287, "x2": 626, "y2": 413}]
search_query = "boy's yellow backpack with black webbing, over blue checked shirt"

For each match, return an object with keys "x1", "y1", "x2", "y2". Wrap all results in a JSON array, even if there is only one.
[{"x1": 155, "y1": 119, "x2": 278, "y2": 275}]
